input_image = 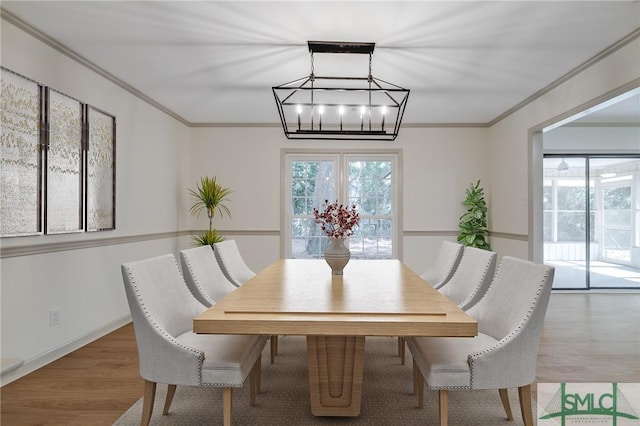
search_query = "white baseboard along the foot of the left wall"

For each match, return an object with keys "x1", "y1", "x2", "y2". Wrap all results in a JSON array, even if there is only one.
[{"x1": 0, "y1": 315, "x2": 131, "y2": 386}]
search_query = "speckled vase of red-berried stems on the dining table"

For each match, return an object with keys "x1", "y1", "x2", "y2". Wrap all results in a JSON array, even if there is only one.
[{"x1": 313, "y1": 200, "x2": 360, "y2": 275}]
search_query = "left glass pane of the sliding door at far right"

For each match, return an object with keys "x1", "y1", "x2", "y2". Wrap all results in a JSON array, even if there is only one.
[{"x1": 543, "y1": 156, "x2": 594, "y2": 289}]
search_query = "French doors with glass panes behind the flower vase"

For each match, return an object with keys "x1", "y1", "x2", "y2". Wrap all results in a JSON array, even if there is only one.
[{"x1": 283, "y1": 153, "x2": 399, "y2": 259}]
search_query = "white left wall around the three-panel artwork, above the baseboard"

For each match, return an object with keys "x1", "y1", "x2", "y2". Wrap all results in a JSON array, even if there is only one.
[{"x1": 0, "y1": 20, "x2": 189, "y2": 384}]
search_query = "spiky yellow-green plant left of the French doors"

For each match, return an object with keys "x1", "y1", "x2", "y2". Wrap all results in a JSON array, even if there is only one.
[{"x1": 189, "y1": 176, "x2": 233, "y2": 246}]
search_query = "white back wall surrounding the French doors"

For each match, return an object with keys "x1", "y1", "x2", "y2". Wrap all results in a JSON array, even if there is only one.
[{"x1": 185, "y1": 127, "x2": 487, "y2": 270}]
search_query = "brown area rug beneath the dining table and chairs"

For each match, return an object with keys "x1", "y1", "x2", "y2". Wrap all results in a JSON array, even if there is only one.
[{"x1": 115, "y1": 336, "x2": 535, "y2": 426}]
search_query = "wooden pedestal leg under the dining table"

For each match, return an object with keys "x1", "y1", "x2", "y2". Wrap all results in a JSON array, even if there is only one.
[{"x1": 307, "y1": 336, "x2": 364, "y2": 417}]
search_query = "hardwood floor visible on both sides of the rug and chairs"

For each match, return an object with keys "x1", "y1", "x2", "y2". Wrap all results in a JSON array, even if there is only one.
[{"x1": 0, "y1": 293, "x2": 640, "y2": 426}]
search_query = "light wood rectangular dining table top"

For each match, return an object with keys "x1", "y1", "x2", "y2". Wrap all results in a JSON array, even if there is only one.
[{"x1": 193, "y1": 259, "x2": 478, "y2": 337}]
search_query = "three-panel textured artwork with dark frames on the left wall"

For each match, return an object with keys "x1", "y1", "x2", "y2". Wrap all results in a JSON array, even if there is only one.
[{"x1": 0, "y1": 68, "x2": 115, "y2": 237}]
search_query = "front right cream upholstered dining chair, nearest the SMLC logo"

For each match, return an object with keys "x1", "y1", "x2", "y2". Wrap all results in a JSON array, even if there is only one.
[{"x1": 406, "y1": 256, "x2": 554, "y2": 426}]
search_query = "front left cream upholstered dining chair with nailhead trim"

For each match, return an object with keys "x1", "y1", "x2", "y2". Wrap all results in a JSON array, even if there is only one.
[{"x1": 122, "y1": 254, "x2": 266, "y2": 425}]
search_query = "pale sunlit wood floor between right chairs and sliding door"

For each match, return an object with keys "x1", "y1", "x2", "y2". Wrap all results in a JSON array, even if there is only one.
[{"x1": 536, "y1": 293, "x2": 640, "y2": 383}]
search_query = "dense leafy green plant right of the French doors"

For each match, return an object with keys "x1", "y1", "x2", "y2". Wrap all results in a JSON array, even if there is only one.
[{"x1": 458, "y1": 180, "x2": 491, "y2": 250}]
